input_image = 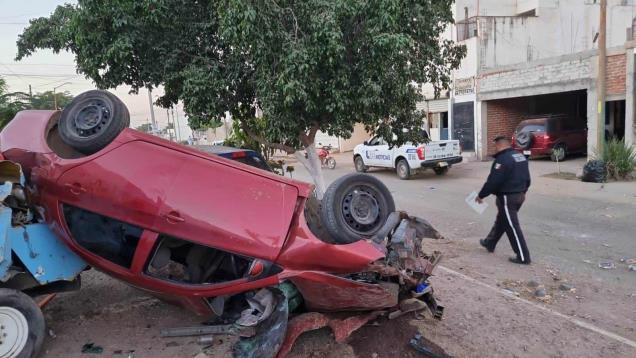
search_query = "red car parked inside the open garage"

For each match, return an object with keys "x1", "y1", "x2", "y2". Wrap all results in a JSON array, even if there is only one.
[{"x1": 512, "y1": 114, "x2": 587, "y2": 161}]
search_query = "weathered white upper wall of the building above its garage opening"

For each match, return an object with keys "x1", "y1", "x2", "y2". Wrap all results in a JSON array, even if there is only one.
[{"x1": 456, "y1": 0, "x2": 636, "y2": 69}]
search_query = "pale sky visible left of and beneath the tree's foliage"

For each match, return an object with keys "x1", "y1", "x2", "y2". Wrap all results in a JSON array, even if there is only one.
[{"x1": 0, "y1": 0, "x2": 191, "y2": 139}]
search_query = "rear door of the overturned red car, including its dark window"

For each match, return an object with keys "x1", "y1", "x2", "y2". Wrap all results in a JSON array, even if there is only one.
[{"x1": 56, "y1": 141, "x2": 183, "y2": 271}]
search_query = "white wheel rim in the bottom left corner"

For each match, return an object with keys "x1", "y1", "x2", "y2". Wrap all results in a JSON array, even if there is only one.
[{"x1": 0, "y1": 307, "x2": 29, "y2": 358}]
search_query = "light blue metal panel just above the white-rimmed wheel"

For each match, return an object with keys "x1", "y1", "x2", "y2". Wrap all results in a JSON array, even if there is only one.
[{"x1": 8, "y1": 224, "x2": 88, "y2": 285}]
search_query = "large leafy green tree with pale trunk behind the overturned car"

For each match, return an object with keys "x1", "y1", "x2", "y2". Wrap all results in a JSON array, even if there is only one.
[{"x1": 17, "y1": 0, "x2": 465, "y2": 196}]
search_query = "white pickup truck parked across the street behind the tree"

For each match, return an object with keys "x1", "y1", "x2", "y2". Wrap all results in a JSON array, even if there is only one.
[{"x1": 353, "y1": 136, "x2": 462, "y2": 179}]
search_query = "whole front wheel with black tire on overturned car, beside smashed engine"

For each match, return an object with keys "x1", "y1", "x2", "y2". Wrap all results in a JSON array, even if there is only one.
[{"x1": 320, "y1": 174, "x2": 395, "y2": 244}]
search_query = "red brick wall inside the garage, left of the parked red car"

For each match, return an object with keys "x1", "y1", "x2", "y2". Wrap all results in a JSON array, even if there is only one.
[{"x1": 486, "y1": 98, "x2": 528, "y2": 155}]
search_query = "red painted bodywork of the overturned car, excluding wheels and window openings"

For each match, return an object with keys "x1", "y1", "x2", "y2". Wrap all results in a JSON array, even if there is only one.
[{"x1": 0, "y1": 111, "x2": 428, "y2": 315}]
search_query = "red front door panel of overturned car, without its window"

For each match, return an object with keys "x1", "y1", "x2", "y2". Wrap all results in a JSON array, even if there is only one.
[{"x1": 156, "y1": 155, "x2": 298, "y2": 261}]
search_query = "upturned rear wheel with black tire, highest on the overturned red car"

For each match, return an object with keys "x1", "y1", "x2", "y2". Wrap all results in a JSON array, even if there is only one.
[{"x1": 58, "y1": 90, "x2": 130, "y2": 155}]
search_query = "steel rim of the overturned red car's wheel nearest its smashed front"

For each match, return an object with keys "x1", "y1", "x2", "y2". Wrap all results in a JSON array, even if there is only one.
[{"x1": 342, "y1": 185, "x2": 382, "y2": 234}]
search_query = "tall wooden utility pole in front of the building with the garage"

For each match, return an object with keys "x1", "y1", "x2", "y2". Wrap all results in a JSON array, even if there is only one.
[{"x1": 596, "y1": 0, "x2": 607, "y2": 155}]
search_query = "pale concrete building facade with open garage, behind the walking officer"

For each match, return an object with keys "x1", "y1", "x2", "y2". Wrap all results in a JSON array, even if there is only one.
[{"x1": 449, "y1": 0, "x2": 636, "y2": 159}]
